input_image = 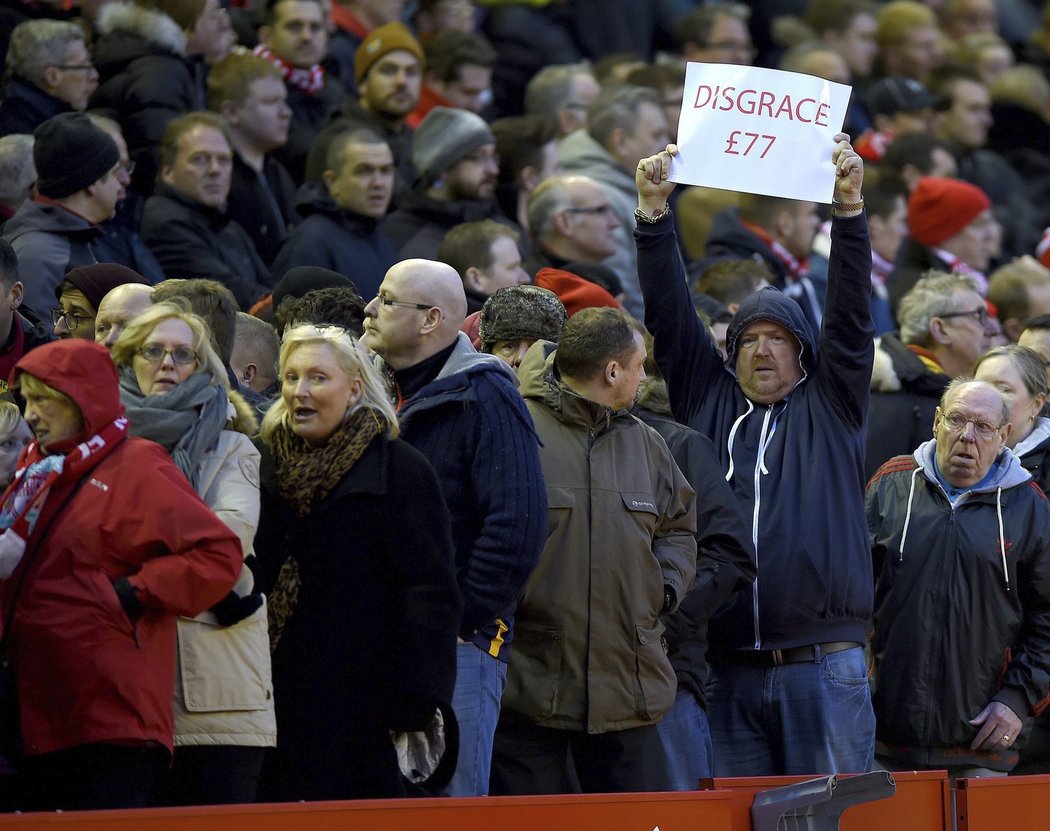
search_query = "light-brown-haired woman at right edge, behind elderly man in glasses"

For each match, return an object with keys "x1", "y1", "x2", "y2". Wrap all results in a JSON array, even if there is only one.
[{"x1": 973, "y1": 344, "x2": 1050, "y2": 491}]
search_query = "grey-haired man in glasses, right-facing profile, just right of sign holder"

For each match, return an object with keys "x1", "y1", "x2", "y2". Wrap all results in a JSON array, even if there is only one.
[{"x1": 864, "y1": 272, "x2": 1000, "y2": 477}]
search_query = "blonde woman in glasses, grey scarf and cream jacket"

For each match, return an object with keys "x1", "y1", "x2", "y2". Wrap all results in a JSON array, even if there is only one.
[{"x1": 112, "y1": 303, "x2": 275, "y2": 805}]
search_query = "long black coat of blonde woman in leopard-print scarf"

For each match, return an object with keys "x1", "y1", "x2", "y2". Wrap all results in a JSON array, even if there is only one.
[{"x1": 255, "y1": 438, "x2": 460, "y2": 802}]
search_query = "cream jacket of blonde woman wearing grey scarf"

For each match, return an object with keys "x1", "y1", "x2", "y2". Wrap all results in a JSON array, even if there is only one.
[{"x1": 174, "y1": 392, "x2": 277, "y2": 747}]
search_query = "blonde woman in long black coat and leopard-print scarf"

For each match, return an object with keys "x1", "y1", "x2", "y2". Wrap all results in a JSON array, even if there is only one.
[{"x1": 256, "y1": 325, "x2": 460, "y2": 802}]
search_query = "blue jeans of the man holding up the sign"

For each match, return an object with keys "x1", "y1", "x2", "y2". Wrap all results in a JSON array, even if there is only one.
[{"x1": 708, "y1": 646, "x2": 875, "y2": 776}]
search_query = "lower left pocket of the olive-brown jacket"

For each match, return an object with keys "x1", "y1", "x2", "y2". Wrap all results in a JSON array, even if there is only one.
[{"x1": 503, "y1": 621, "x2": 565, "y2": 719}]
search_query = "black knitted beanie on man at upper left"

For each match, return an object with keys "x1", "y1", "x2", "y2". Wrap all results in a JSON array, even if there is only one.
[{"x1": 33, "y1": 112, "x2": 121, "y2": 200}]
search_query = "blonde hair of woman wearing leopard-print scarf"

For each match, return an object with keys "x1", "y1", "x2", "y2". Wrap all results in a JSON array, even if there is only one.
[{"x1": 259, "y1": 324, "x2": 401, "y2": 445}]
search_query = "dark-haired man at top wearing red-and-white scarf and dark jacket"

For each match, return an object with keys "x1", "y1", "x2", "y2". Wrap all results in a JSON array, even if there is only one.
[{"x1": 255, "y1": 0, "x2": 347, "y2": 183}]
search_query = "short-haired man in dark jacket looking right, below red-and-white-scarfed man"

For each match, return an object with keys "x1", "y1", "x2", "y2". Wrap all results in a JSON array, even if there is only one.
[{"x1": 208, "y1": 53, "x2": 295, "y2": 266}]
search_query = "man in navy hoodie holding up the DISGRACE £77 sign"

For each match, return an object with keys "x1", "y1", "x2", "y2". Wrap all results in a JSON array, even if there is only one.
[{"x1": 635, "y1": 133, "x2": 875, "y2": 776}]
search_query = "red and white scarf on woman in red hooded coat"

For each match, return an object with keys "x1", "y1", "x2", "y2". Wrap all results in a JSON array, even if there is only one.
[{"x1": 0, "y1": 415, "x2": 128, "y2": 580}]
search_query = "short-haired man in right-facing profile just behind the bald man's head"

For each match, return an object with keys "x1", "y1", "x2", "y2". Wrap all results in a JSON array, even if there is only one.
[{"x1": 435, "y1": 220, "x2": 529, "y2": 314}]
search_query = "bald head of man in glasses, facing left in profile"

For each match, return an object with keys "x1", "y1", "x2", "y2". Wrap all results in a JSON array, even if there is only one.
[{"x1": 362, "y1": 259, "x2": 466, "y2": 370}]
